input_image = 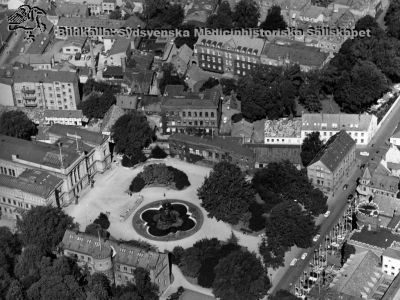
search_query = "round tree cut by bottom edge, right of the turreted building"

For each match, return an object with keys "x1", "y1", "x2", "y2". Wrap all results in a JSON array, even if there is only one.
[{"x1": 213, "y1": 251, "x2": 270, "y2": 300}]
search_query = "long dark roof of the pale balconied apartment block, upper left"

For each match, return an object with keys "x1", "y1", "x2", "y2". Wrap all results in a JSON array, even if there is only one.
[{"x1": 14, "y1": 69, "x2": 78, "y2": 83}]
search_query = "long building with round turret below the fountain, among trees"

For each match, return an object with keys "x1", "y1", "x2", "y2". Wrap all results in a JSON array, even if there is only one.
[{"x1": 59, "y1": 230, "x2": 171, "y2": 294}]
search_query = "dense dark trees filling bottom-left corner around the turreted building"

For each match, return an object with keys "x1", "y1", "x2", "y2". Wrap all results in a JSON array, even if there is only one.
[{"x1": 0, "y1": 206, "x2": 158, "y2": 300}]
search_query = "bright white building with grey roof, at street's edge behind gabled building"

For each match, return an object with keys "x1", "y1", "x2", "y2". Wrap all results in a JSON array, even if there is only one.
[{"x1": 301, "y1": 113, "x2": 378, "y2": 146}]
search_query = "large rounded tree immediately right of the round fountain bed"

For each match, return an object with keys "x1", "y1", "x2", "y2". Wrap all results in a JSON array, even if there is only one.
[{"x1": 197, "y1": 162, "x2": 254, "y2": 224}]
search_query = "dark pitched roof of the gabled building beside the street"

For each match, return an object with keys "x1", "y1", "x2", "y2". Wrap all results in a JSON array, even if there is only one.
[{"x1": 310, "y1": 130, "x2": 356, "y2": 172}]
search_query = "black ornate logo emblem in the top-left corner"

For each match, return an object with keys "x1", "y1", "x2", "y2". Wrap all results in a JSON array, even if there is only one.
[{"x1": 7, "y1": 5, "x2": 46, "y2": 43}]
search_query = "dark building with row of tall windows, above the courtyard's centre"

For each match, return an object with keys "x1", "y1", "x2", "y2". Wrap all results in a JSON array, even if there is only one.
[{"x1": 161, "y1": 89, "x2": 221, "y2": 134}]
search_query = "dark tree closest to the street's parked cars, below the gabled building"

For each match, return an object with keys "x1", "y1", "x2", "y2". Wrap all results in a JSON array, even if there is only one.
[{"x1": 265, "y1": 201, "x2": 318, "y2": 248}]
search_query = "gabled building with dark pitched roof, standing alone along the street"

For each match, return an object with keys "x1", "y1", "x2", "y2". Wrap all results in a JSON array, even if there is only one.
[{"x1": 307, "y1": 130, "x2": 356, "y2": 194}]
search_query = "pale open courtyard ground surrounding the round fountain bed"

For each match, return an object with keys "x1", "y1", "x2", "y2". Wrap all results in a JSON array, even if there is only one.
[{"x1": 65, "y1": 158, "x2": 260, "y2": 252}]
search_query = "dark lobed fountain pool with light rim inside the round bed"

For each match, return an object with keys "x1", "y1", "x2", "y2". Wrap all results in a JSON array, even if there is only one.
[{"x1": 141, "y1": 202, "x2": 196, "y2": 236}]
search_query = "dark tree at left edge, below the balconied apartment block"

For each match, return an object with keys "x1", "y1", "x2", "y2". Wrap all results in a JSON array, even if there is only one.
[{"x1": 0, "y1": 110, "x2": 38, "y2": 141}]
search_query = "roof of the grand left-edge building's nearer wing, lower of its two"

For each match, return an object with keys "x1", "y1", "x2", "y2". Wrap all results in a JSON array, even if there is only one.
[{"x1": 0, "y1": 169, "x2": 63, "y2": 199}]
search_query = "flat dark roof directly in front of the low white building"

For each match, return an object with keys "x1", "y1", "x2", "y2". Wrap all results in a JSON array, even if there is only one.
[{"x1": 251, "y1": 145, "x2": 302, "y2": 165}]
